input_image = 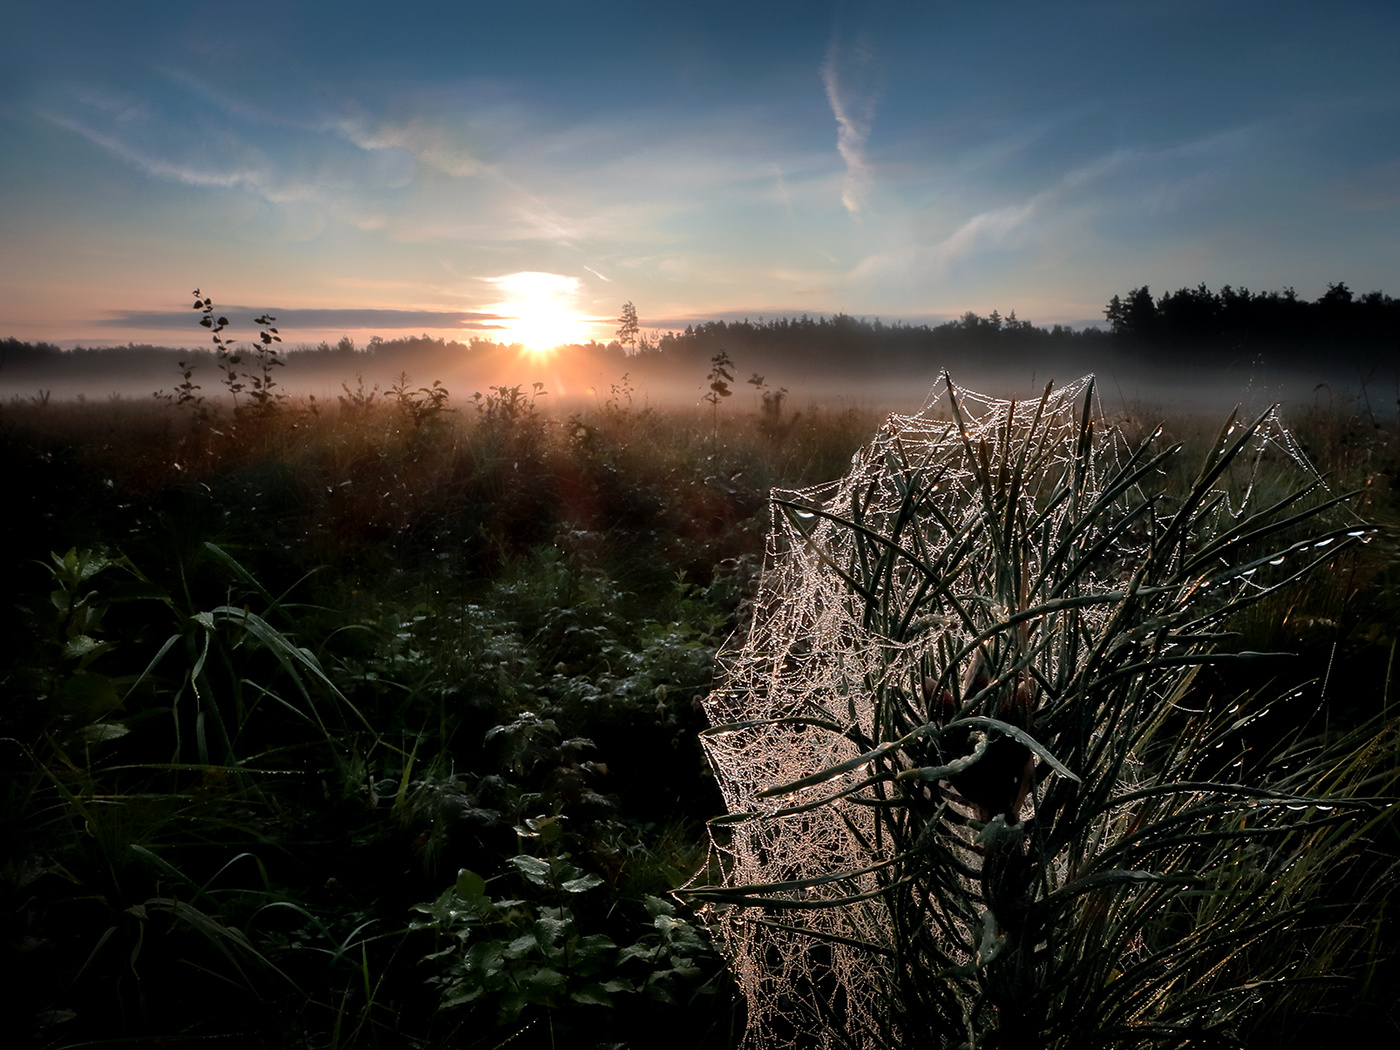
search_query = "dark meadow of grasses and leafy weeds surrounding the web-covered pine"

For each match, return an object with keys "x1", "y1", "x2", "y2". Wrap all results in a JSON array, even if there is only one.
[{"x1": 0, "y1": 386, "x2": 1400, "y2": 1050}]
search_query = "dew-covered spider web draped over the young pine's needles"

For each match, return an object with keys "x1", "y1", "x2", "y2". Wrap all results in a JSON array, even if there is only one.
[{"x1": 692, "y1": 377, "x2": 1315, "y2": 1050}]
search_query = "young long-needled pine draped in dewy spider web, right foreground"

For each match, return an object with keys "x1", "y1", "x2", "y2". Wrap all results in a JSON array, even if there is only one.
[{"x1": 680, "y1": 379, "x2": 1397, "y2": 1050}]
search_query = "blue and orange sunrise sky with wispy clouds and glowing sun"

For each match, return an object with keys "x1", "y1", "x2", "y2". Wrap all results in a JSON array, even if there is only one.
[{"x1": 0, "y1": 0, "x2": 1400, "y2": 354}]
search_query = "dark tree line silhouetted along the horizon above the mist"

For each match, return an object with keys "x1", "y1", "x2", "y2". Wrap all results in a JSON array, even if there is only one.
[{"x1": 0, "y1": 283, "x2": 1400, "y2": 392}]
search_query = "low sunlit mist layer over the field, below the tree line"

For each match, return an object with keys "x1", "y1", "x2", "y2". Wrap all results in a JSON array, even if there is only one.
[{"x1": 0, "y1": 347, "x2": 1366, "y2": 414}]
